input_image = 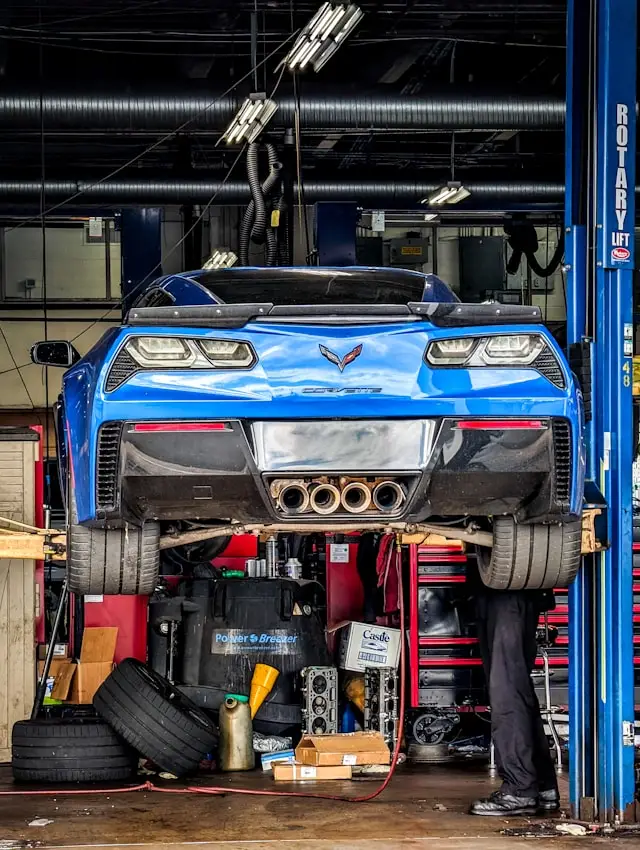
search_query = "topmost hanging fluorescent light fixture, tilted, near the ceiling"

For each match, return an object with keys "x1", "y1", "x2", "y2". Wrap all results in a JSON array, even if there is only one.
[{"x1": 283, "y1": 3, "x2": 364, "y2": 72}]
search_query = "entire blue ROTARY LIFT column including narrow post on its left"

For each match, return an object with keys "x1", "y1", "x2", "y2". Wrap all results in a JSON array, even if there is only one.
[{"x1": 565, "y1": 0, "x2": 637, "y2": 823}]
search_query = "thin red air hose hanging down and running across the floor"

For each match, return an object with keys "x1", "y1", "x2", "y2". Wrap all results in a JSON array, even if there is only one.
[{"x1": 0, "y1": 542, "x2": 406, "y2": 803}]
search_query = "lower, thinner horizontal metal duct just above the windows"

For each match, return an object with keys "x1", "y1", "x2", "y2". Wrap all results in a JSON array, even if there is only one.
[{"x1": 0, "y1": 178, "x2": 564, "y2": 205}]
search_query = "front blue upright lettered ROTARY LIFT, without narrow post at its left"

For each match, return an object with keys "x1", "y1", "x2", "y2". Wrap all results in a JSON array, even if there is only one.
[{"x1": 594, "y1": 0, "x2": 637, "y2": 822}]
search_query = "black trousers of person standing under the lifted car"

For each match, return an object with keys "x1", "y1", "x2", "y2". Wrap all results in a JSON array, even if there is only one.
[{"x1": 478, "y1": 589, "x2": 556, "y2": 797}]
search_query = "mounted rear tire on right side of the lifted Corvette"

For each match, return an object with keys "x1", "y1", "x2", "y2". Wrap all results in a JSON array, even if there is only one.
[{"x1": 478, "y1": 517, "x2": 582, "y2": 590}]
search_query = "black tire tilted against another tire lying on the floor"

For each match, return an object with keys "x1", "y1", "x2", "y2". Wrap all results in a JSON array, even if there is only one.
[{"x1": 93, "y1": 658, "x2": 217, "y2": 776}]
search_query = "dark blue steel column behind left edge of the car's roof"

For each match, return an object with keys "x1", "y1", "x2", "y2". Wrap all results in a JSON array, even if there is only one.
[{"x1": 120, "y1": 207, "x2": 162, "y2": 311}]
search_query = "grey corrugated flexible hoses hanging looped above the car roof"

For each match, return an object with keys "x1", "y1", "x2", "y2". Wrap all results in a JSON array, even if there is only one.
[{"x1": 239, "y1": 142, "x2": 282, "y2": 266}]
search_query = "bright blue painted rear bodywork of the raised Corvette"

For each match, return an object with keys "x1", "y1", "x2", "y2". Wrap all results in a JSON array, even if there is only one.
[{"x1": 58, "y1": 269, "x2": 584, "y2": 522}]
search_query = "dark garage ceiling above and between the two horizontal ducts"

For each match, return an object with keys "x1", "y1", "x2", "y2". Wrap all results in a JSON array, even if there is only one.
[{"x1": 0, "y1": 0, "x2": 566, "y2": 195}]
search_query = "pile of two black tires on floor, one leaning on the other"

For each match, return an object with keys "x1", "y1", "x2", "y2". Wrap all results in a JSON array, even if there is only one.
[{"x1": 12, "y1": 658, "x2": 217, "y2": 783}]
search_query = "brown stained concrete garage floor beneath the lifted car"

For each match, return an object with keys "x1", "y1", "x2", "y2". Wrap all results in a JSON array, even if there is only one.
[{"x1": 0, "y1": 765, "x2": 640, "y2": 850}]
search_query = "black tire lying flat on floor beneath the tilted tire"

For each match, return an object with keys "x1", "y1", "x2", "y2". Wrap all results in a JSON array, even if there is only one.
[{"x1": 11, "y1": 718, "x2": 138, "y2": 782}]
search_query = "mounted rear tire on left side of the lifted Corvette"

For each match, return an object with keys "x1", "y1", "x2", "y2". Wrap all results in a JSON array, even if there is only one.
[{"x1": 67, "y1": 480, "x2": 160, "y2": 596}]
